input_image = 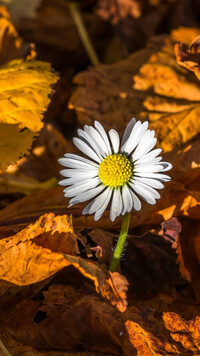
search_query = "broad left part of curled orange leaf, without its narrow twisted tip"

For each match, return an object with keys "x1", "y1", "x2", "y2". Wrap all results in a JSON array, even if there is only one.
[{"x1": 0, "y1": 213, "x2": 78, "y2": 286}]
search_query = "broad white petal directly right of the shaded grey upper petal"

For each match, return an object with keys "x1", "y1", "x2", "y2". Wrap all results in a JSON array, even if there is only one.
[{"x1": 122, "y1": 121, "x2": 148, "y2": 154}]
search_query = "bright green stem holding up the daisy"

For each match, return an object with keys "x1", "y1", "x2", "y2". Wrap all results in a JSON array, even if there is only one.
[{"x1": 109, "y1": 213, "x2": 130, "y2": 272}]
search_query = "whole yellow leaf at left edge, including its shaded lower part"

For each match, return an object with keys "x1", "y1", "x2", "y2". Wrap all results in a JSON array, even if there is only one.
[{"x1": 0, "y1": 60, "x2": 58, "y2": 169}]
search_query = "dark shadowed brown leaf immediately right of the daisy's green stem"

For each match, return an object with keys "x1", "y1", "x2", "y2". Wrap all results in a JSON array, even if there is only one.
[{"x1": 121, "y1": 229, "x2": 181, "y2": 305}]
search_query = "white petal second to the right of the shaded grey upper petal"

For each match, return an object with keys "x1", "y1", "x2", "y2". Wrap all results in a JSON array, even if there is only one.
[{"x1": 132, "y1": 130, "x2": 157, "y2": 162}]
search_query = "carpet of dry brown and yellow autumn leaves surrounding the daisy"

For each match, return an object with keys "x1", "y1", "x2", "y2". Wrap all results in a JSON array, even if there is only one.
[{"x1": 0, "y1": 0, "x2": 200, "y2": 356}]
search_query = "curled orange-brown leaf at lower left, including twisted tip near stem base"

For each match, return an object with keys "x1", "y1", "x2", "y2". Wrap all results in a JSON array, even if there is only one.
[{"x1": 0, "y1": 213, "x2": 127, "y2": 311}]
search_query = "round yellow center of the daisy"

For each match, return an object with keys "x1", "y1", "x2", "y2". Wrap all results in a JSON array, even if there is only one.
[{"x1": 99, "y1": 153, "x2": 133, "y2": 188}]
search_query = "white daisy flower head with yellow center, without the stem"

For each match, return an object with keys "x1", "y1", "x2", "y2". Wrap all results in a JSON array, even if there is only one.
[{"x1": 59, "y1": 119, "x2": 172, "y2": 221}]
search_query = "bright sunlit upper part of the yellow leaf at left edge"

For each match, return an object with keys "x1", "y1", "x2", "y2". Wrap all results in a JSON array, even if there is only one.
[{"x1": 0, "y1": 60, "x2": 58, "y2": 132}]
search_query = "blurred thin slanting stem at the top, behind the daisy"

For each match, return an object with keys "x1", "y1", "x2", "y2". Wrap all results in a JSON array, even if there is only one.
[{"x1": 69, "y1": 1, "x2": 100, "y2": 66}]
